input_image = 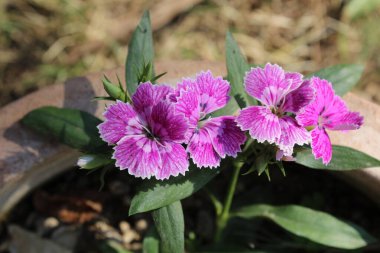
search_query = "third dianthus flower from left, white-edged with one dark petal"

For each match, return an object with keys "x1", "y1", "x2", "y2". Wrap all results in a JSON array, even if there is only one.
[{"x1": 236, "y1": 63, "x2": 314, "y2": 159}]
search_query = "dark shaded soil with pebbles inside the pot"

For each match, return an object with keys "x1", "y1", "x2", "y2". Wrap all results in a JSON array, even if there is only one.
[{"x1": 0, "y1": 161, "x2": 380, "y2": 253}]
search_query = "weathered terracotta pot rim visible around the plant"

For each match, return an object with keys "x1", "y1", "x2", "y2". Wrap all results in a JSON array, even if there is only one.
[{"x1": 0, "y1": 61, "x2": 380, "y2": 219}]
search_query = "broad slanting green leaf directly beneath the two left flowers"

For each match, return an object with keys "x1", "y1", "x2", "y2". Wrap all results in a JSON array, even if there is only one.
[{"x1": 129, "y1": 166, "x2": 220, "y2": 215}]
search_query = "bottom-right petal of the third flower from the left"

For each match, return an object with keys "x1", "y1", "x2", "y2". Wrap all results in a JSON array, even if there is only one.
[{"x1": 276, "y1": 116, "x2": 310, "y2": 156}]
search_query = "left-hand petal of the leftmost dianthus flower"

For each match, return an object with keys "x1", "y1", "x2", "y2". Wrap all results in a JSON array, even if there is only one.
[{"x1": 98, "y1": 101, "x2": 142, "y2": 144}]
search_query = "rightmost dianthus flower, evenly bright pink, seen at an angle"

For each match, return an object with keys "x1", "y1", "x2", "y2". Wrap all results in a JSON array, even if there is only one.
[{"x1": 296, "y1": 77, "x2": 363, "y2": 165}]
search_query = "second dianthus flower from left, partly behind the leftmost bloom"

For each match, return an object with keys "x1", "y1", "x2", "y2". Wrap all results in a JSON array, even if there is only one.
[{"x1": 171, "y1": 71, "x2": 246, "y2": 168}]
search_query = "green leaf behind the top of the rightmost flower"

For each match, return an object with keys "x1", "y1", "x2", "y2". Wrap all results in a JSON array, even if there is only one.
[{"x1": 308, "y1": 64, "x2": 364, "y2": 96}]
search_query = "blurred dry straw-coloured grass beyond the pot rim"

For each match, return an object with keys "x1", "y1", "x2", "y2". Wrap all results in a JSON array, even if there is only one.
[{"x1": 0, "y1": 0, "x2": 380, "y2": 106}]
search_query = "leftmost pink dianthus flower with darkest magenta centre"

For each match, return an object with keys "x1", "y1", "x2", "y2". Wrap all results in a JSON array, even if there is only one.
[{"x1": 98, "y1": 82, "x2": 189, "y2": 179}]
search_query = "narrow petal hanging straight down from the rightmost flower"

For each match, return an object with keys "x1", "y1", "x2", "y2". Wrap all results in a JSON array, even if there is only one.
[{"x1": 311, "y1": 128, "x2": 332, "y2": 165}]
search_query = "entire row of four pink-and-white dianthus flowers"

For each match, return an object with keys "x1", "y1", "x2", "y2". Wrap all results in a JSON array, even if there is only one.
[{"x1": 98, "y1": 64, "x2": 363, "y2": 179}]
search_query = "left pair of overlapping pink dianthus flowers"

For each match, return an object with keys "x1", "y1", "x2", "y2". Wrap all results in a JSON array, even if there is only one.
[{"x1": 99, "y1": 72, "x2": 246, "y2": 179}]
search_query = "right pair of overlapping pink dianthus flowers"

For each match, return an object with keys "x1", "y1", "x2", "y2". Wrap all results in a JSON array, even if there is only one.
[{"x1": 237, "y1": 64, "x2": 363, "y2": 164}]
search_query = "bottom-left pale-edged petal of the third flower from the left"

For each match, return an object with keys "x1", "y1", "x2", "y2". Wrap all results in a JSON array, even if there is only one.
[{"x1": 236, "y1": 106, "x2": 281, "y2": 143}]
